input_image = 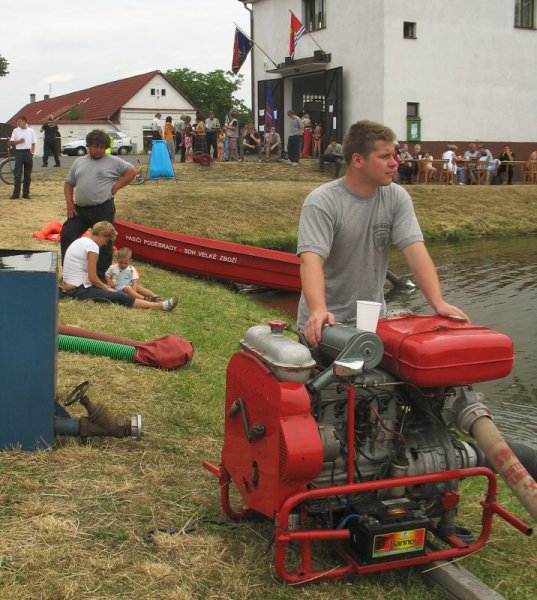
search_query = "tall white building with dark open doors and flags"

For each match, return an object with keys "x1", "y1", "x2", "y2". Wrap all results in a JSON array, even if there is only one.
[{"x1": 244, "y1": 0, "x2": 537, "y2": 148}]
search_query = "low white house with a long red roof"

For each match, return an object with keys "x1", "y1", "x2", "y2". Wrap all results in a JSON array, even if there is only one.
[{"x1": 9, "y1": 71, "x2": 196, "y2": 154}]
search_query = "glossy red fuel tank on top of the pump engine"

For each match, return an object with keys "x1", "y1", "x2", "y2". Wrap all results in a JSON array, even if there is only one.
[{"x1": 377, "y1": 314, "x2": 513, "y2": 387}]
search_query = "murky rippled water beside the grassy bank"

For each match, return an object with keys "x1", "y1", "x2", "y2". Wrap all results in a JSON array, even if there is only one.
[{"x1": 251, "y1": 236, "x2": 537, "y2": 449}]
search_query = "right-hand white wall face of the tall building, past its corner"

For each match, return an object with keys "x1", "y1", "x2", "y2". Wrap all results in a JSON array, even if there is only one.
[{"x1": 384, "y1": 0, "x2": 537, "y2": 142}]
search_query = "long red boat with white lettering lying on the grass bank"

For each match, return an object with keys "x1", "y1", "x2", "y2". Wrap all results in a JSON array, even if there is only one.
[{"x1": 115, "y1": 219, "x2": 302, "y2": 292}]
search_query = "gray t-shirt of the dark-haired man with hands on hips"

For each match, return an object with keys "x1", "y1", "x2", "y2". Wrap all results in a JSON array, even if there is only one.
[{"x1": 65, "y1": 154, "x2": 132, "y2": 206}]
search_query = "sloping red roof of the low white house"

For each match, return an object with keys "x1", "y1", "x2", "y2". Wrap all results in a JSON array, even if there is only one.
[{"x1": 8, "y1": 71, "x2": 188, "y2": 125}]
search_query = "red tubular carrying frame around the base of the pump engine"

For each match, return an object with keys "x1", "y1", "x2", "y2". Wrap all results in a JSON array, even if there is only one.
[{"x1": 203, "y1": 462, "x2": 532, "y2": 584}]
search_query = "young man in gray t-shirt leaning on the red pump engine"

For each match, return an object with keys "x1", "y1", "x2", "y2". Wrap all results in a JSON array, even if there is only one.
[{"x1": 297, "y1": 121, "x2": 468, "y2": 347}]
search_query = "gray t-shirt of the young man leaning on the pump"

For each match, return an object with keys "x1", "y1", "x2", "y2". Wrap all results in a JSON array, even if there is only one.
[{"x1": 297, "y1": 179, "x2": 423, "y2": 329}]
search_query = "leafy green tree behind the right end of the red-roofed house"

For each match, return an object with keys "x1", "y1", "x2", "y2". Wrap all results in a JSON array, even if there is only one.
[{"x1": 166, "y1": 69, "x2": 251, "y2": 123}]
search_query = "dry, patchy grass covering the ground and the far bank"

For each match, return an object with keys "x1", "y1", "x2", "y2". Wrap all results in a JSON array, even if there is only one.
[{"x1": 0, "y1": 163, "x2": 537, "y2": 600}]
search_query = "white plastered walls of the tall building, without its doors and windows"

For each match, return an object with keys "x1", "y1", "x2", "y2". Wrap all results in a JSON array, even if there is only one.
[{"x1": 253, "y1": 0, "x2": 537, "y2": 142}]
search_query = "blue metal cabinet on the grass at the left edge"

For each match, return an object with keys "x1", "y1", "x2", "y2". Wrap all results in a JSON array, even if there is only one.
[{"x1": 0, "y1": 250, "x2": 58, "y2": 450}]
